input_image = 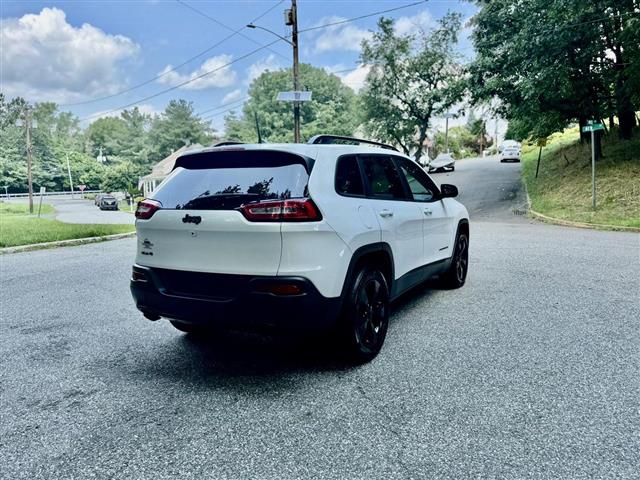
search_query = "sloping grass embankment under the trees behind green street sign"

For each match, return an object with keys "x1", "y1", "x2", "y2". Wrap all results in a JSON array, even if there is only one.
[{"x1": 522, "y1": 127, "x2": 640, "y2": 227}]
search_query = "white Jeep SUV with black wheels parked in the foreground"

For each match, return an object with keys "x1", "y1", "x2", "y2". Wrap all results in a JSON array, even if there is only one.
[{"x1": 131, "y1": 135, "x2": 469, "y2": 361}]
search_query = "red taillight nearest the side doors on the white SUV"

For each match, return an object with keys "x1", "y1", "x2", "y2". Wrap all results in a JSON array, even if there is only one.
[{"x1": 239, "y1": 198, "x2": 322, "y2": 222}]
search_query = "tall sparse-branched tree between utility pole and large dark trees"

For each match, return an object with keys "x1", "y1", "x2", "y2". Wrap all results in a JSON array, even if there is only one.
[{"x1": 361, "y1": 13, "x2": 465, "y2": 160}]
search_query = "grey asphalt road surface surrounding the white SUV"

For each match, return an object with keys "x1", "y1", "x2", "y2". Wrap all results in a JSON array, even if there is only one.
[{"x1": 0, "y1": 159, "x2": 640, "y2": 479}]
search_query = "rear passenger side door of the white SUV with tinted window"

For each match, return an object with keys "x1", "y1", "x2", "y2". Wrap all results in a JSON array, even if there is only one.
[{"x1": 359, "y1": 154, "x2": 424, "y2": 279}]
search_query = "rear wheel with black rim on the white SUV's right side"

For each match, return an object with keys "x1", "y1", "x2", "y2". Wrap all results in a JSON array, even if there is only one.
[{"x1": 338, "y1": 266, "x2": 389, "y2": 364}]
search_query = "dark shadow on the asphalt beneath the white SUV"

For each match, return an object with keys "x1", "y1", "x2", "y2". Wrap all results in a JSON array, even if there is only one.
[{"x1": 122, "y1": 282, "x2": 444, "y2": 393}]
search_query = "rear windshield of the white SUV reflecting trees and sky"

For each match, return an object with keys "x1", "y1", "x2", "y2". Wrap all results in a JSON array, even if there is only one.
[{"x1": 151, "y1": 151, "x2": 309, "y2": 210}]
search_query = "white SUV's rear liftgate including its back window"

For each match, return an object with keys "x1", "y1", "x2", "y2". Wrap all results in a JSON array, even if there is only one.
[{"x1": 136, "y1": 150, "x2": 309, "y2": 275}]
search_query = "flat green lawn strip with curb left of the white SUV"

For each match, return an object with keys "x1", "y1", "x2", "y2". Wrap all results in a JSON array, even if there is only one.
[{"x1": 0, "y1": 202, "x2": 135, "y2": 247}]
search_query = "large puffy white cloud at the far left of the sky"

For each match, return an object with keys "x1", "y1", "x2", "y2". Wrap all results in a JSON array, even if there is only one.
[{"x1": 0, "y1": 8, "x2": 140, "y2": 103}]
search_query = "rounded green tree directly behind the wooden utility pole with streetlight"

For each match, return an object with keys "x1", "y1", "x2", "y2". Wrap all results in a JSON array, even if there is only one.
[{"x1": 225, "y1": 64, "x2": 360, "y2": 142}]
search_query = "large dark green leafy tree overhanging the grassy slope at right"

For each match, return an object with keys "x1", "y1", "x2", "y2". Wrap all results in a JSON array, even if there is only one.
[{"x1": 471, "y1": 0, "x2": 640, "y2": 138}]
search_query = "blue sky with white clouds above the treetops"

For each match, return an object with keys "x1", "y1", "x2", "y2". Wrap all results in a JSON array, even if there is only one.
[{"x1": 0, "y1": 0, "x2": 475, "y2": 131}]
